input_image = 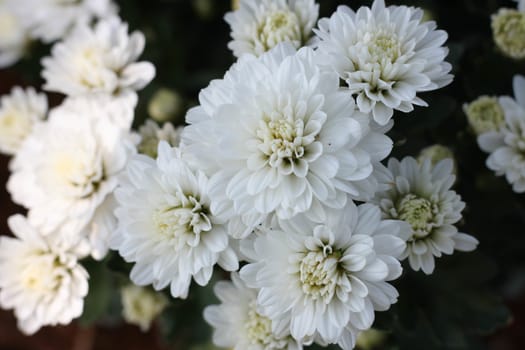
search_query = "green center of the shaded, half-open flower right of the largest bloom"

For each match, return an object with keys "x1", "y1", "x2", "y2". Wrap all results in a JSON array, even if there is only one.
[{"x1": 397, "y1": 193, "x2": 436, "y2": 238}]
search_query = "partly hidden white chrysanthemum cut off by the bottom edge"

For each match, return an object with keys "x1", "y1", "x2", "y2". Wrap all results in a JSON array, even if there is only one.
[{"x1": 204, "y1": 272, "x2": 303, "y2": 350}]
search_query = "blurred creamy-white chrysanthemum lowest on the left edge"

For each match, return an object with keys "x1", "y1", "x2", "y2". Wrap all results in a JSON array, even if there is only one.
[{"x1": 0, "y1": 215, "x2": 88, "y2": 334}]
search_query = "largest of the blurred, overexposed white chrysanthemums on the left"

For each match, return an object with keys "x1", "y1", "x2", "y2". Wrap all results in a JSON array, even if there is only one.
[{"x1": 7, "y1": 95, "x2": 136, "y2": 259}]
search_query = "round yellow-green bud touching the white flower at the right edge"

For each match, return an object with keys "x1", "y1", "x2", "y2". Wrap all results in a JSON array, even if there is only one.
[{"x1": 463, "y1": 96, "x2": 505, "y2": 135}]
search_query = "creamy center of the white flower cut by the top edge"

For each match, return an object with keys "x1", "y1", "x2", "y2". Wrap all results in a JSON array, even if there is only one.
[{"x1": 258, "y1": 10, "x2": 301, "y2": 50}]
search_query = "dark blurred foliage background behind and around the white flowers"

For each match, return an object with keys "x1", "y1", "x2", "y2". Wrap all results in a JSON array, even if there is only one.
[{"x1": 0, "y1": 0, "x2": 525, "y2": 350}]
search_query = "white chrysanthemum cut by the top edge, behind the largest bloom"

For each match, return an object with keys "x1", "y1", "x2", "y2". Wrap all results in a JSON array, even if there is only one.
[{"x1": 224, "y1": 0, "x2": 319, "y2": 57}]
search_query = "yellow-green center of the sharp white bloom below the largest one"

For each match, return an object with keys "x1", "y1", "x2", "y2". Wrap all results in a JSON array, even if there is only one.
[{"x1": 299, "y1": 247, "x2": 338, "y2": 300}]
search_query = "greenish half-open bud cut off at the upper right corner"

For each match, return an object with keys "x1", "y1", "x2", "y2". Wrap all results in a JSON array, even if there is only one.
[{"x1": 492, "y1": 8, "x2": 525, "y2": 59}]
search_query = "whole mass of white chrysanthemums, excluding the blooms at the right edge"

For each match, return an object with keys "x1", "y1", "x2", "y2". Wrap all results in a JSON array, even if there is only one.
[{"x1": 0, "y1": 0, "x2": 477, "y2": 350}]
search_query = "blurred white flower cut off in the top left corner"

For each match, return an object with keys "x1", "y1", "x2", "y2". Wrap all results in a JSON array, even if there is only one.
[{"x1": 0, "y1": 0, "x2": 29, "y2": 68}]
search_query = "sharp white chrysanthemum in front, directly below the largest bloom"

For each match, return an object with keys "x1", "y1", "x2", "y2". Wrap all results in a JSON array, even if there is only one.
[{"x1": 240, "y1": 200, "x2": 405, "y2": 349}]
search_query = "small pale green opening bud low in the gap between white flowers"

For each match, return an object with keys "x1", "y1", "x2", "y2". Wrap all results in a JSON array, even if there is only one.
[{"x1": 120, "y1": 284, "x2": 168, "y2": 332}]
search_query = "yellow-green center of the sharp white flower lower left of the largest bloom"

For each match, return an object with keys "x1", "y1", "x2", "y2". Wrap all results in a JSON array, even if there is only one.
[{"x1": 153, "y1": 195, "x2": 212, "y2": 244}]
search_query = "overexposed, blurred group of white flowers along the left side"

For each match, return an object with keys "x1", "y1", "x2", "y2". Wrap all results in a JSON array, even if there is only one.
[{"x1": 0, "y1": 0, "x2": 155, "y2": 333}]
